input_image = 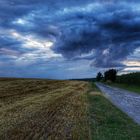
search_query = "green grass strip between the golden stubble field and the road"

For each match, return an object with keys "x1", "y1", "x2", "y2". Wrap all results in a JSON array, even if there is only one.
[{"x1": 87, "y1": 83, "x2": 140, "y2": 140}]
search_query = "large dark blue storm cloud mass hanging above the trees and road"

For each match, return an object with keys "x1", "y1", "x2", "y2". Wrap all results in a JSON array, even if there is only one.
[{"x1": 51, "y1": 3, "x2": 140, "y2": 67}]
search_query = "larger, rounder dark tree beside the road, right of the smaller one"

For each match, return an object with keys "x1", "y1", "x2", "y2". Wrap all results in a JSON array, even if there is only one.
[{"x1": 104, "y1": 69, "x2": 117, "y2": 82}]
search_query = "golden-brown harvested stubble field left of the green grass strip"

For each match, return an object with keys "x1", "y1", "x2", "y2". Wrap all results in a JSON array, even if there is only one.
[{"x1": 0, "y1": 79, "x2": 89, "y2": 140}]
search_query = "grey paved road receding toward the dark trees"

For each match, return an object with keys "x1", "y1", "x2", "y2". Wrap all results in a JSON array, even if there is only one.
[{"x1": 96, "y1": 83, "x2": 140, "y2": 124}]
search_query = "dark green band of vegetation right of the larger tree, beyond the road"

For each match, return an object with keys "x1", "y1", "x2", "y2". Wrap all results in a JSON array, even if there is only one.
[{"x1": 116, "y1": 72, "x2": 140, "y2": 86}]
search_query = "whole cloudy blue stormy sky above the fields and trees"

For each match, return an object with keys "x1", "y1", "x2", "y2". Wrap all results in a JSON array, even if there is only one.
[{"x1": 0, "y1": 0, "x2": 140, "y2": 79}]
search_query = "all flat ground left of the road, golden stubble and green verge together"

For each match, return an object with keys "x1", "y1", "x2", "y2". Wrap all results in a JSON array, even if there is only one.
[{"x1": 0, "y1": 78, "x2": 140, "y2": 140}]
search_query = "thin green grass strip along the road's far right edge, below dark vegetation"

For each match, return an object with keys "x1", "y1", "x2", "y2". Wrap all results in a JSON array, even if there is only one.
[{"x1": 106, "y1": 83, "x2": 140, "y2": 94}]
